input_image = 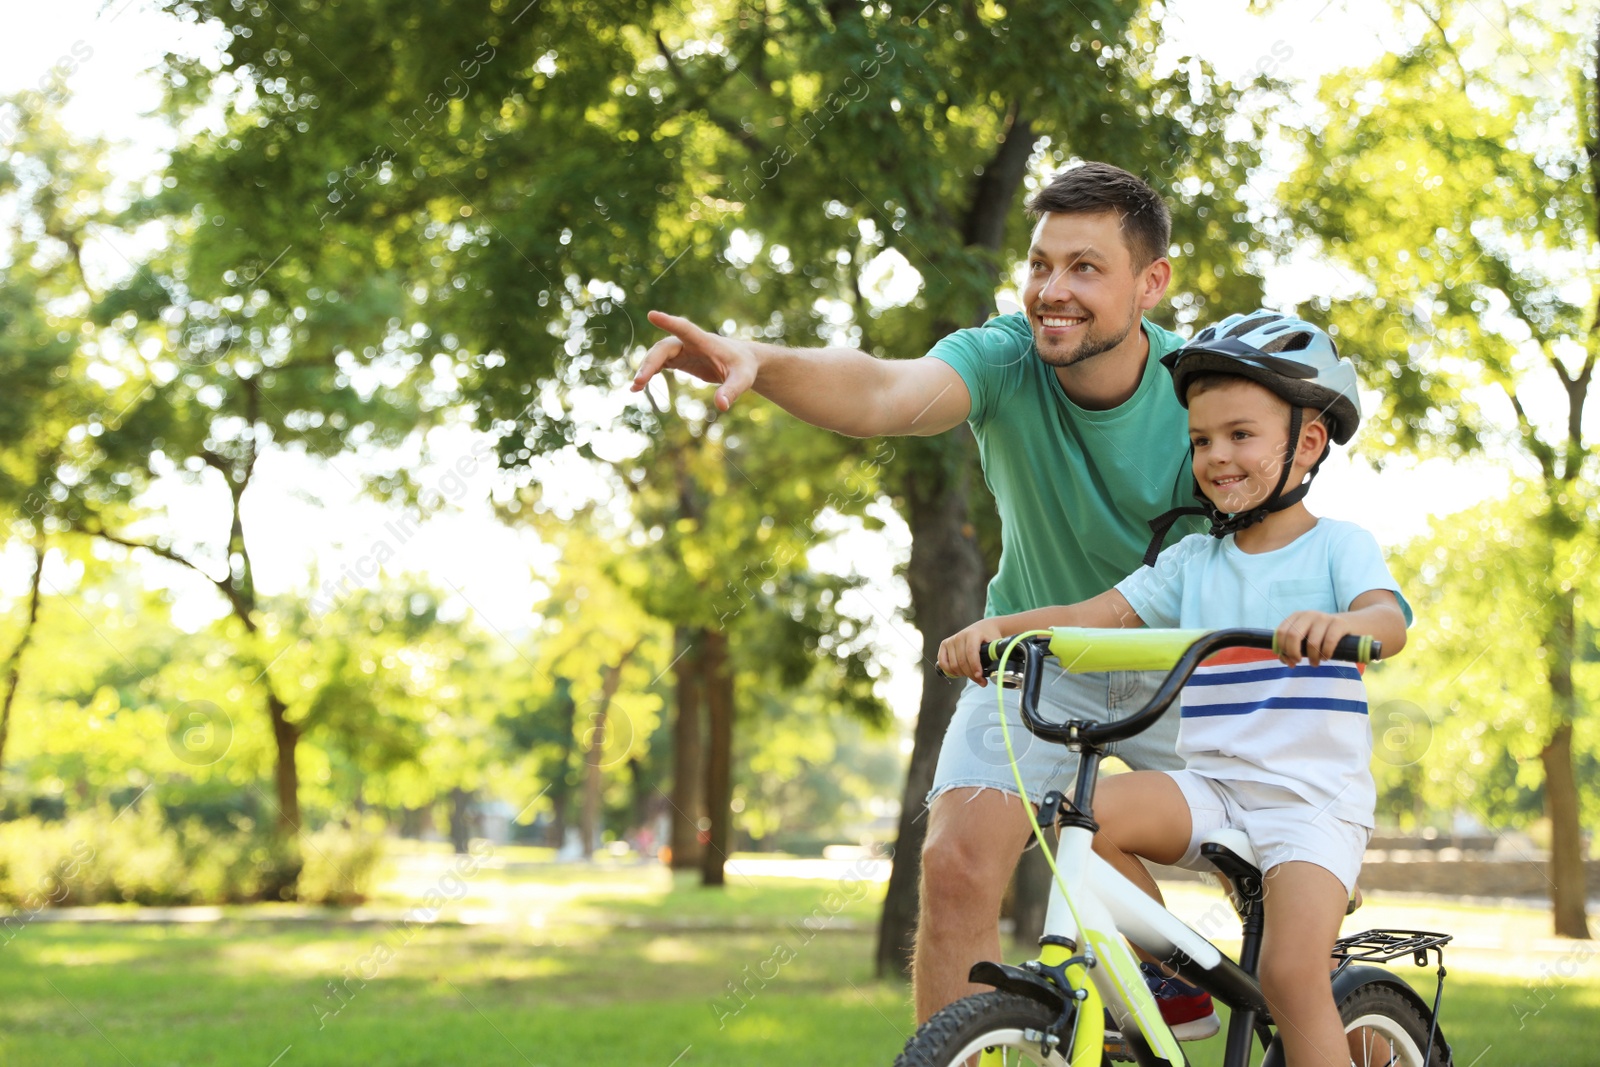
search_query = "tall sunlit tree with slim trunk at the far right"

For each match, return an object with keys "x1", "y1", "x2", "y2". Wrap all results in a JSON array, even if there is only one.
[{"x1": 1280, "y1": 0, "x2": 1600, "y2": 937}]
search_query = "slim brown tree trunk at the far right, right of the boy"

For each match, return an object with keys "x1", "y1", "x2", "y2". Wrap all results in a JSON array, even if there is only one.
[{"x1": 1539, "y1": 593, "x2": 1589, "y2": 939}]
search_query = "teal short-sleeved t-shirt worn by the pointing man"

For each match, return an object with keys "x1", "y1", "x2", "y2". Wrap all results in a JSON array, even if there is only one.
[{"x1": 928, "y1": 314, "x2": 1205, "y2": 616}]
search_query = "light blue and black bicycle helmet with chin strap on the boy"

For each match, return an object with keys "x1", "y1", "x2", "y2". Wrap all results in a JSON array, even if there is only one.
[{"x1": 1144, "y1": 310, "x2": 1362, "y2": 565}]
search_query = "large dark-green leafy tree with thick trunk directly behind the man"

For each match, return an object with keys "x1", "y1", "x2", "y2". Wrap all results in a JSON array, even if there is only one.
[{"x1": 150, "y1": 0, "x2": 1259, "y2": 953}]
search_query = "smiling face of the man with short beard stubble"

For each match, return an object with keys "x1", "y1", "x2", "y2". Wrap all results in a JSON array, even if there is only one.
[{"x1": 1022, "y1": 211, "x2": 1165, "y2": 366}]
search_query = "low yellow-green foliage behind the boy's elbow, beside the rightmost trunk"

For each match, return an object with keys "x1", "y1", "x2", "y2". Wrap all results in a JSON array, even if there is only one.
[{"x1": 1373, "y1": 482, "x2": 1600, "y2": 825}]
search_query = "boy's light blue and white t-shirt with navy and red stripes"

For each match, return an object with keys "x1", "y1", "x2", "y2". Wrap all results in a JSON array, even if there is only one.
[{"x1": 1117, "y1": 518, "x2": 1411, "y2": 825}]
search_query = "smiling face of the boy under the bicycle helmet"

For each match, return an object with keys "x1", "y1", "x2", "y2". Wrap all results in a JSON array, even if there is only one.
[{"x1": 1189, "y1": 378, "x2": 1304, "y2": 514}]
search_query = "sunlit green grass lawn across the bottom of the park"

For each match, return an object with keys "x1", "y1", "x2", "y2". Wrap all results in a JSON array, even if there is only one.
[{"x1": 0, "y1": 864, "x2": 1600, "y2": 1067}]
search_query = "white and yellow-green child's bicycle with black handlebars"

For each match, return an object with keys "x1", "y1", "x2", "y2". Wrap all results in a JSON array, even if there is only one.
[{"x1": 894, "y1": 627, "x2": 1451, "y2": 1067}]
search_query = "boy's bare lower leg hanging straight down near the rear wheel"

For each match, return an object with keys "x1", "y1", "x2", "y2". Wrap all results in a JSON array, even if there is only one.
[{"x1": 1261, "y1": 861, "x2": 1350, "y2": 1067}]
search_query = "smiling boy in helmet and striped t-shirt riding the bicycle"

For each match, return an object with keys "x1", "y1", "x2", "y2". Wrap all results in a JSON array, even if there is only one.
[{"x1": 939, "y1": 312, "x2": 1411, "y2": 1067}]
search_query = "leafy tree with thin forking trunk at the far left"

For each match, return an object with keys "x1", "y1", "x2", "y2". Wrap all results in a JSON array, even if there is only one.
[{"x1": 6, "y1": 81, "x2": 444, "y2": 870}]
